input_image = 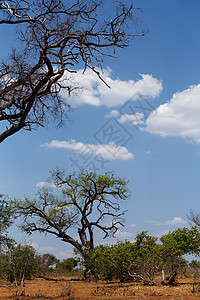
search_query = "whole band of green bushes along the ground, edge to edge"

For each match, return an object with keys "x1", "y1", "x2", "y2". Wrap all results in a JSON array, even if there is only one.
[{"x1": 0, "y1": 227, "x2": 200, "y2": 286}]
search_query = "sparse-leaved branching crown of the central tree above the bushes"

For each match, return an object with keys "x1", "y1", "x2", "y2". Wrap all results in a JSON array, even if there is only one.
[{"x1": 16, "y1": 169, "x2": 130, "y2": 254}]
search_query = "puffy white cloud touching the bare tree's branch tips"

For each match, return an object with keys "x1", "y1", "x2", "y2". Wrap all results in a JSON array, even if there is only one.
[{"x1": 61, "y1": 68, "x2": 163, "y2": 107}]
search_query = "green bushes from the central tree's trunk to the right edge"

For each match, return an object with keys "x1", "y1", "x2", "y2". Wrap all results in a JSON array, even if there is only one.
[{"x1": 83, "y1": 227, "x2": 200, "y2": 285}]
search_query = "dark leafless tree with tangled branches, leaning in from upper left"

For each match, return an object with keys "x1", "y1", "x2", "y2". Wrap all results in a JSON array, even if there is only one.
[{"x1": 0, "y1": 0, "x2": 146, "y2": 142}]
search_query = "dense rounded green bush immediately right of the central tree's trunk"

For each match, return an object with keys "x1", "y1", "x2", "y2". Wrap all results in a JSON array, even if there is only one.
[{"x1": 88, "y1": 232, "x2": 159, "y2": 285}]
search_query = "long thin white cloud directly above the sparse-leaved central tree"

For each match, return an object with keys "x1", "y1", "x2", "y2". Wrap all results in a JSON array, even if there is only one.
[{"x1": 41, "y1": 140, "x2": 134, "y2": 160}]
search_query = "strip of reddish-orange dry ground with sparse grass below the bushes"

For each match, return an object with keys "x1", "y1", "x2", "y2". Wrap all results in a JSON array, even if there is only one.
[{"x1": 0, "y1": 278, "x2": 200, "y2": 300}]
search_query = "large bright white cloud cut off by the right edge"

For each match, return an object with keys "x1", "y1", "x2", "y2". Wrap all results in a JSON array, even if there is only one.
[{"x1": 146, "y1": 84, "x2": 200, "y2": 143}]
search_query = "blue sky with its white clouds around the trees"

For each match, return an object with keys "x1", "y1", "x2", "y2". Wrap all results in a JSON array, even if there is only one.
[{"x1": 0, "y1": 0, "x2": 200, "y2": 258}]
